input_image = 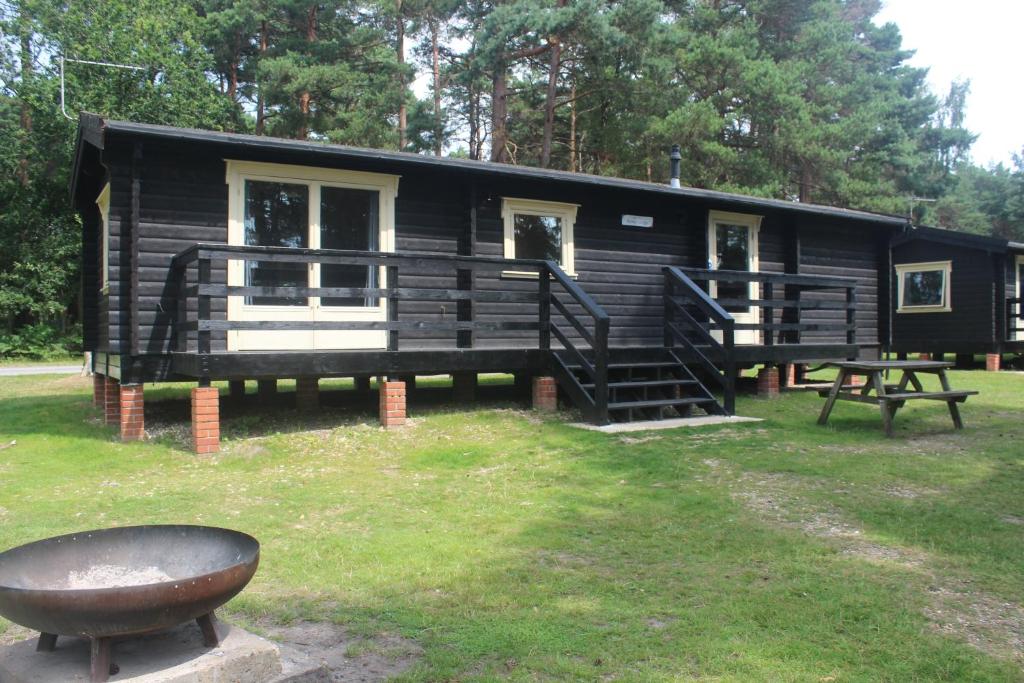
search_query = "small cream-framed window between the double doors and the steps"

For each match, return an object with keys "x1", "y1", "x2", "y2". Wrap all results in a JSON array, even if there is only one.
[{"x1": 502, "y1": 198, "x2": 579, "y2": 276}]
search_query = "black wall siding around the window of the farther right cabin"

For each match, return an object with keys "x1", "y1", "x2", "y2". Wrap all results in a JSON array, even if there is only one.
[{"x1": 892, "y1": 240, "x2": 995, "y2": 353}]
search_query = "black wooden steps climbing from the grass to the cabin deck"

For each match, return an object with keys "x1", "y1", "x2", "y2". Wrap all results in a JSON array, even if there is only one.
[{"x1": 553, "y1": 349, "x2": 726, "y2": 422}]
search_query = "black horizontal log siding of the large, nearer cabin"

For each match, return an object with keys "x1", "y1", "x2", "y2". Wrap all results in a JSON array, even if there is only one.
[{"x1": 97, "y1": 139, "x2": 888, "y2": 362}]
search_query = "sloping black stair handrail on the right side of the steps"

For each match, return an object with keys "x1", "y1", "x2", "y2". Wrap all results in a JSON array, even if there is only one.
[{"x1": 664, "y1": 265, "x2": 736, "y2": 415}]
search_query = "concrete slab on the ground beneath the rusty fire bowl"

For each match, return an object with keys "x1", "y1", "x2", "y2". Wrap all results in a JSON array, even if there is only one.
[{"x1": 0, "y1": 622, "x2": 282, "y2": 683}]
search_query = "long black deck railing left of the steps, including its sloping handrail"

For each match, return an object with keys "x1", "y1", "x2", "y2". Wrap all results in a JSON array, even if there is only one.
[{"x1": 172, "y1": 244, "x2": 610, "y2": 405}]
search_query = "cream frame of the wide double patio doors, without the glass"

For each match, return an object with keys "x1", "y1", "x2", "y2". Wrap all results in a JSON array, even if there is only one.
[{"x1": 224, "y1": 159, "x2": 400, "y2": 351}]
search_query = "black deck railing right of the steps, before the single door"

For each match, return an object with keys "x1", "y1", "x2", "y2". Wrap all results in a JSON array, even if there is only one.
[{"x1": 680, "y1": 268, "x2": 857, "y2": 346}]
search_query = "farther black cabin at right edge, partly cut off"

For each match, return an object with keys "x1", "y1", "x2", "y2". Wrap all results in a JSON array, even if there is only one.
[{"x1": 892, "y1": 227, "x2": 1024, "y2": 368}]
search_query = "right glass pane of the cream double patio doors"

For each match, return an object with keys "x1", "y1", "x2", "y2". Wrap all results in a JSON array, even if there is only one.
[{"x1": 321, "y1": 187, "x2": 380, "y2": 306}]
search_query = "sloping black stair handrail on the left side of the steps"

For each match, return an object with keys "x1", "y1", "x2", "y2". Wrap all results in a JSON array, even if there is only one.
[{"x1": 540, "y1": 260, "x2": 611, "y2": 424}]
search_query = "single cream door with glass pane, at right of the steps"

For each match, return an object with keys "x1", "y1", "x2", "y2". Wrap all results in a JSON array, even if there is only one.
[{"x1": 708, "y1": 211, "x2": 761, "y2": 344}]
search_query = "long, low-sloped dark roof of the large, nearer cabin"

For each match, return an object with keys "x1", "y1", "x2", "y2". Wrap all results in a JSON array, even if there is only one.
[{"x1": 72, "y1": 114, "x2": 907, "y2": 228}]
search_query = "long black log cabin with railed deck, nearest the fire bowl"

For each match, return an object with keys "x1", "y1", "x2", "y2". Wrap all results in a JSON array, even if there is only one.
[{"x1": 72, "y1": 115, "x2": 905, "y2": 446}]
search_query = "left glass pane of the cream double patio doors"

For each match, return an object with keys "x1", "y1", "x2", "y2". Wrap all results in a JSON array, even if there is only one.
[{"x1": 245, "y1": 180, "x2": 309, "y2": 306}]
